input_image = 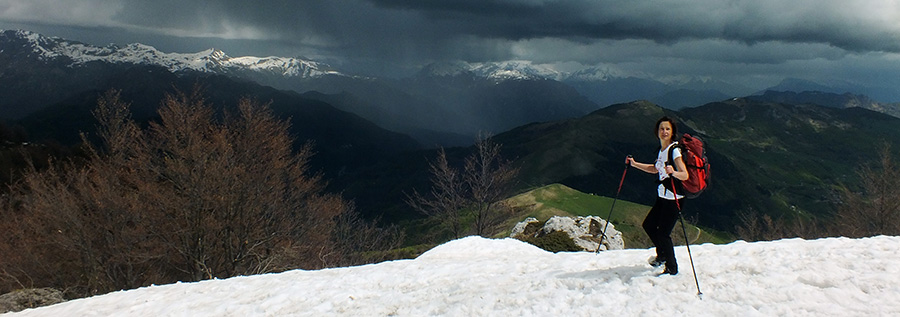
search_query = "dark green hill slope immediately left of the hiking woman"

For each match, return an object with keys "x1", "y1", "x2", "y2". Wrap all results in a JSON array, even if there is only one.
[{"x1": 495, "y1": 101, "x2": 666, "y2": 186}]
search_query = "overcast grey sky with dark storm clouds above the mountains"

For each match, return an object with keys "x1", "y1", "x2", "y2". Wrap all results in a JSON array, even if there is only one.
[{"x1": 0, "y1": 0, "x2": 900, "y2": 102}]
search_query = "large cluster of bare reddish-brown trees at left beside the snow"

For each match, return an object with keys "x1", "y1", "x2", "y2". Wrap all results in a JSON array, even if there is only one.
[{"x1": 0, "y1": 90, "x2": 393, "y2": 296}]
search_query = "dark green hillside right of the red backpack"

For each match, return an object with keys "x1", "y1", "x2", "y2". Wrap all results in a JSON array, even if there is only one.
[{"x1": 682, "y1": 99, "x2": 900, "y2": 219}]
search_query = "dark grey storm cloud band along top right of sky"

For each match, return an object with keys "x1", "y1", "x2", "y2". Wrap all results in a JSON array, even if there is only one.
[{"x1": 358, "y1": 0, "x2": 900, "y2": 52}]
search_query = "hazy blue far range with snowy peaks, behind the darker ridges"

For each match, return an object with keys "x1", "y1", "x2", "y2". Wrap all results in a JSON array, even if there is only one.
[{"x1": 7, "y1": 30, "x2": 892, "y2": 146}]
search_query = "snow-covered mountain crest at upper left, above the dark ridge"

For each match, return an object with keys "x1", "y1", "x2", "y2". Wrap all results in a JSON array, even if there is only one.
[{"x1": 2, "y1": 30, "x2": 341, "y2": 78}]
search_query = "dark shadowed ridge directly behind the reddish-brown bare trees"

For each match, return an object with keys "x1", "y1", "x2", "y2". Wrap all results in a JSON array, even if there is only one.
[{"x1": 17, "y1": 66, "x2": 420, "y2": 183}]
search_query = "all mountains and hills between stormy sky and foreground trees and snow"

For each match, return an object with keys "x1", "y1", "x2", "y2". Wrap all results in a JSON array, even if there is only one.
[{"x1": 0, "y1": 31, "x2": 900, "y2": 231}]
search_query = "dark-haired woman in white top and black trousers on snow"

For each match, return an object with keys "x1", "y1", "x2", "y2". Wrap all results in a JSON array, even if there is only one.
[{"x1": 625, "y1": 117, "x2": 688, "y2": 275}]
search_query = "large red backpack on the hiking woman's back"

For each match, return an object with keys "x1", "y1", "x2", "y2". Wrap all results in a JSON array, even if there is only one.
[{"x1": 669, "y1": 133, "x2": 709, "y2": 198}]
